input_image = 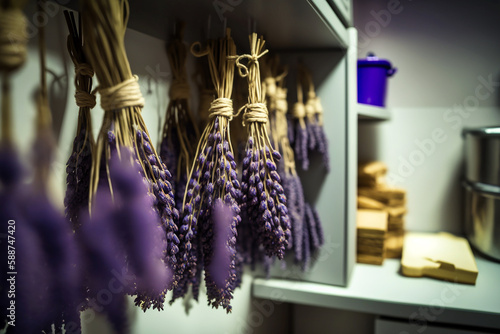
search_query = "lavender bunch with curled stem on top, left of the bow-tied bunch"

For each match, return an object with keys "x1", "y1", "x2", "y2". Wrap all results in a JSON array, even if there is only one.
[{"x1": 171, "y1": 30, "x2": 241, "y2": 312}]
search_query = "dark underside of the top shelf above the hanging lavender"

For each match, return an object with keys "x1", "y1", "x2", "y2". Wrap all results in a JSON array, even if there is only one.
[{"x1": 60, "y1": 0, "x2": 347, "y2": 50}]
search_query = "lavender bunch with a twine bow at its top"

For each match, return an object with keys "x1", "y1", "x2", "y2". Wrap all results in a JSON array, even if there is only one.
[{"x1": 236, "y1": 33, "x2": 291, "y2": 259}]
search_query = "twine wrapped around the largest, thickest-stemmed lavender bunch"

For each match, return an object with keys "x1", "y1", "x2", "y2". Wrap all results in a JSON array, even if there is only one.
[{"x1": 96, "y1": 75, "x2": 144, "y2": 111}]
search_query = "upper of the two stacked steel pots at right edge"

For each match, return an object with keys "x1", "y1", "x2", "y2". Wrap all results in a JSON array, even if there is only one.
[{"x1": 462, "y1": 126, "x2": 500, "y2": 186}]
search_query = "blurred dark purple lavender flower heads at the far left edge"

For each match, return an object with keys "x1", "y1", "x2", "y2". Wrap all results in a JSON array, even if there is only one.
[{"x1": 0, "y1": 149, "x2": 54, "y2": 333}]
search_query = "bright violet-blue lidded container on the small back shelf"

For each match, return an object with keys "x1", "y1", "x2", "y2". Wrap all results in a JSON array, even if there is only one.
[{"x1": 358, "y1": 53, "x2": 397, "y2": 107}]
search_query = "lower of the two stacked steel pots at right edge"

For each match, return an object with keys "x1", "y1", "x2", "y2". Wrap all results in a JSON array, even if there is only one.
[{"x1": 462, "y1": 181, "x2": 500, "y2": 261}]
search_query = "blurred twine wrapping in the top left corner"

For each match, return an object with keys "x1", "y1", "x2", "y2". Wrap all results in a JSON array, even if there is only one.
[{"x1": 0, "y1": 8, "x2": 28, "y2": 70}]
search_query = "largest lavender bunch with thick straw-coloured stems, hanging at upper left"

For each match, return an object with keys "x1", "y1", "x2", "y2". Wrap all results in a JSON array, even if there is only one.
[{"x1": 82, "y1": 0, "x2": 180, "y2": 292}]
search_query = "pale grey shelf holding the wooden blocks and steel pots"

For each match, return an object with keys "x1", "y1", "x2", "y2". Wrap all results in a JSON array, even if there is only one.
[{"x1": 253, "y1": 257, "x2": 500, "y2": 330}]
